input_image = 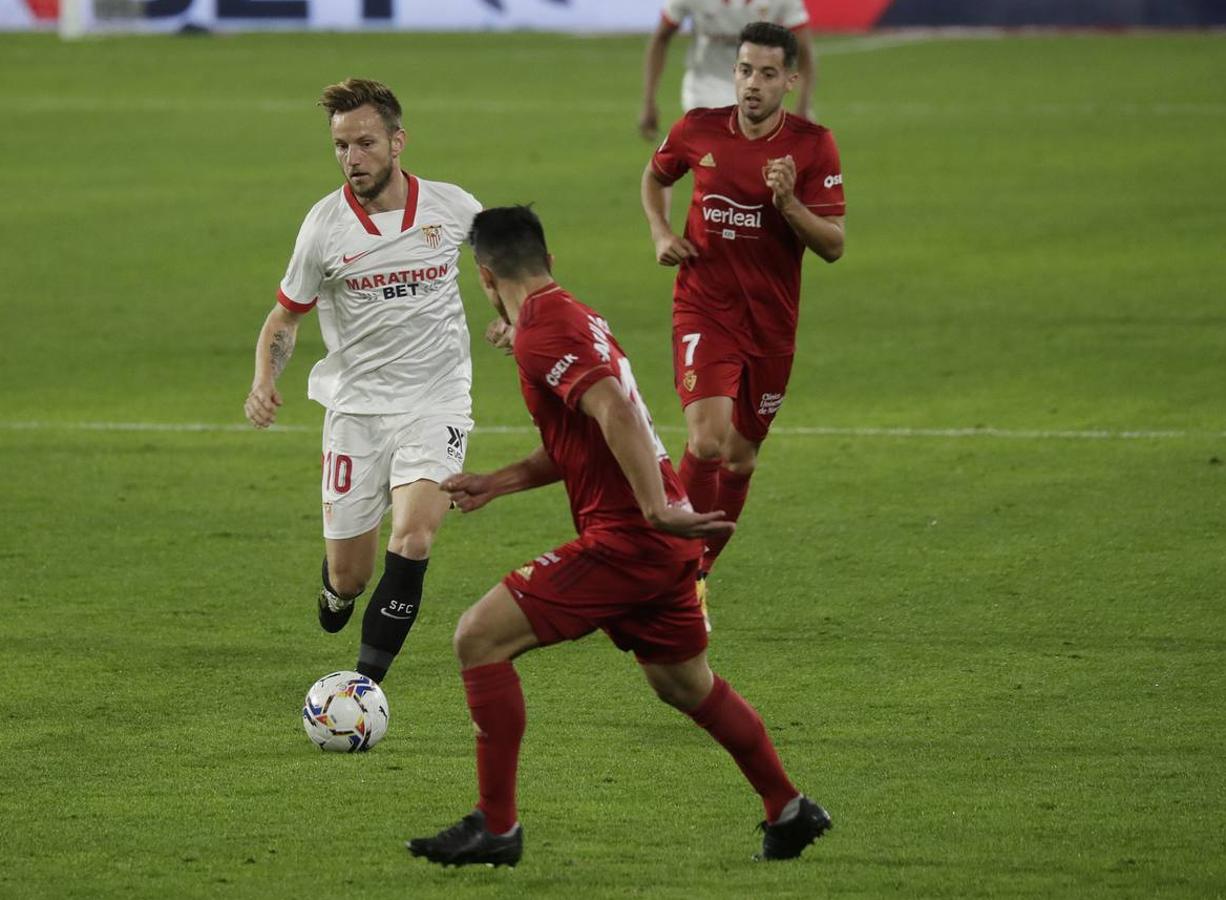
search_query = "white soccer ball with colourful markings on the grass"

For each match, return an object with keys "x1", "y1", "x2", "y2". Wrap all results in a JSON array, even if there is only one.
[{"x1": 303, "y1": 672, "x2": 387, "y2": 753}]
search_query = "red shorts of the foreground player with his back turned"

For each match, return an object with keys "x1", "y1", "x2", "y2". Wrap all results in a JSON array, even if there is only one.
[{"x1": 503, "y1": 537, "x2": 706, "y2": 665}]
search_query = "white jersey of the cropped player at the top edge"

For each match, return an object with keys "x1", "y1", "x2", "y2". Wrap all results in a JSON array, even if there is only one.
[{"x1": 661, "y1": 0, "x2": 809, "y2": 112}]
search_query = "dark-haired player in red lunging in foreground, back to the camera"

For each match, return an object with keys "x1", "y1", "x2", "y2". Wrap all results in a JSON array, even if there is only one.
[{"x1": 407, "y1": 206, "x2": 830, "y2": 866}]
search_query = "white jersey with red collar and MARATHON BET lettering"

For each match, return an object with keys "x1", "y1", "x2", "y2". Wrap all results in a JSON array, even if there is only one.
[{"x1": 278, "y1": 173, "x2": 481, "y2": 416}]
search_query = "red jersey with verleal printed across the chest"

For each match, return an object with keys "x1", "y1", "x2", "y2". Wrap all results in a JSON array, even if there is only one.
[{"x1": 651, "y1": 107, "x2": 846, "y2": 356}]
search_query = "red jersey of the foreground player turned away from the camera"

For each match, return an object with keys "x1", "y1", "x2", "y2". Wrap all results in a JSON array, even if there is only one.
[{"x1": 515, "y1": 284, "x2": 702, "y2": 562}]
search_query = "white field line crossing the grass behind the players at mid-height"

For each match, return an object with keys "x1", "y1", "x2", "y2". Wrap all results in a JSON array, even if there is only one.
[{"x1": 0, "y1": 422, "x2": 1226, "y2": 440}]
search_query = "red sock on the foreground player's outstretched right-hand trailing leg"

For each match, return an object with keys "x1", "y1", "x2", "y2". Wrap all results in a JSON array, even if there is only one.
[{"x1": 689, "y1": 676, "x2": 799, "y2": 822}]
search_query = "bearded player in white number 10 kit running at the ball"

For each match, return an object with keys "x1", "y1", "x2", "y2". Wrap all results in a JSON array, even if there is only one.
[{"x1": 244, "y1": 78, "x2": 481, "y2": 681}]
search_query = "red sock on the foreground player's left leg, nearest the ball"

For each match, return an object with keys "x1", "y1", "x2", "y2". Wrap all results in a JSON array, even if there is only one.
[{"x1": 461, "y1": 662, "x2": 525, "y2": 834}]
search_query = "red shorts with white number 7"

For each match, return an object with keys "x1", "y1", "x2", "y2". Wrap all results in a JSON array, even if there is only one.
[{"x1": 673, "y1": 314, "x2": 792, "y2": 444}]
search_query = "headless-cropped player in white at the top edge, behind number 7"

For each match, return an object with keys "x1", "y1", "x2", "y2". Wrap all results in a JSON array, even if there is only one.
[{"x1": 639, "y1": 0, "x2": 817, "y2": 142}]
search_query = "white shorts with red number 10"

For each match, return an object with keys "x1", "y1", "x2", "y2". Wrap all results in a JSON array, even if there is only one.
[{"x1": 321, "y1": 410, "x2": 472, "y2": 540}]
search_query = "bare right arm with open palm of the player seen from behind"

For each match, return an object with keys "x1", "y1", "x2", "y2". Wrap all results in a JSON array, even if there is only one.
[{"x1": 579, "y1": 375, "x2": 736, "y2": 537}]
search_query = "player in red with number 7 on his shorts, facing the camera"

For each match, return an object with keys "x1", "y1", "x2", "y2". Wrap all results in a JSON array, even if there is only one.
[{"x1": 642, "y1": 22, "x2": 845, "y2": 627}]
